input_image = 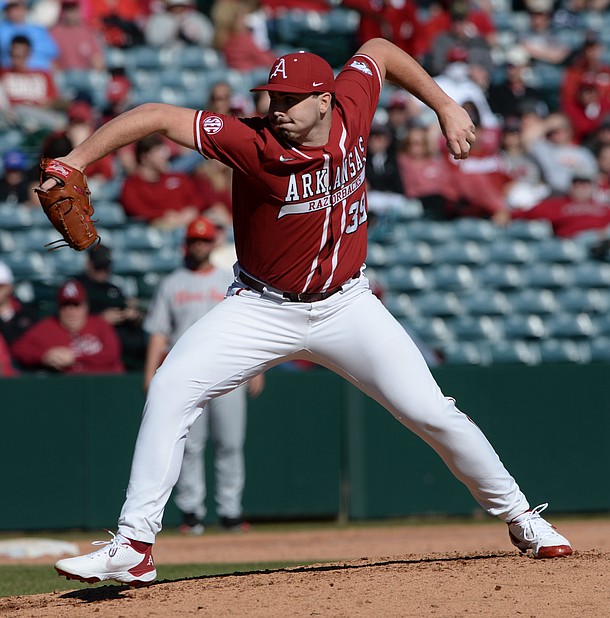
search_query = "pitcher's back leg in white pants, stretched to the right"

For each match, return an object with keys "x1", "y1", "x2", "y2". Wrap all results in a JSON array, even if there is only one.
[{"x1": 309, "y1": 291, "x2": 529, "y2": 521}]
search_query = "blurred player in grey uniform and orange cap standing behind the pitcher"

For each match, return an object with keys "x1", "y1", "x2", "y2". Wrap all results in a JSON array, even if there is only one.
[{"x1": 144, "y1": 217, "x2": 264, "y2": 535}]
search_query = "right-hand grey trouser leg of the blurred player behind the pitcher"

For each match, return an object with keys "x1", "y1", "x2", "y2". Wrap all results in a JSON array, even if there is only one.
[{"x1": 210, "y1": 385, "x2": 247, "y2": 519}]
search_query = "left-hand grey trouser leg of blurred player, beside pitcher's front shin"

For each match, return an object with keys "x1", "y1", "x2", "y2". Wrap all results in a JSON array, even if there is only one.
[{"x1": 174, "y1": 401, "x2": 208, "y2": 521}]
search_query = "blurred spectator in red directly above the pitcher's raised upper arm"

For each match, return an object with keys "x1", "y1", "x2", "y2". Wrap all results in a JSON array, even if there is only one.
[{"x1": 341, "y1": 0, "x2": 422, "y2": 58}]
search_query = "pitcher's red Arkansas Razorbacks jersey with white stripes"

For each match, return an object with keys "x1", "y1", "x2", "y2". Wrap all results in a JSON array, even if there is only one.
[{"x1": 194, "y1": 55, "x2": 383, "y2": 293}]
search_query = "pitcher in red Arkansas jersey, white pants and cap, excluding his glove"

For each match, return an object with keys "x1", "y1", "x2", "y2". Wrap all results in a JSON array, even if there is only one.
[{"x1": 52, "y1": 39, "x2": 572, "y2": 585}]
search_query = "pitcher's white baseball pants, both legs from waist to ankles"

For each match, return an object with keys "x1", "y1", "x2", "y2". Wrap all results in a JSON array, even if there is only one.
[{"x1": 119, "y1": 276, "x2": 529, "y2": 543}]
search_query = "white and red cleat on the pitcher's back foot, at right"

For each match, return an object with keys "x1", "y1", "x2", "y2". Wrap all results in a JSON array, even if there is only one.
[{"x1": 508, "y1": 503, "x2": 572, "y2": 558}]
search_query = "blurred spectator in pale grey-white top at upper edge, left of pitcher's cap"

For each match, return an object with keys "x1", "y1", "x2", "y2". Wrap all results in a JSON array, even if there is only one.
[{"x1": 144, "y1": 0, "x2": 214, "y2": 48}]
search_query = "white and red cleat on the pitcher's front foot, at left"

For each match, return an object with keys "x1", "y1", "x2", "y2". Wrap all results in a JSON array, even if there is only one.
[{"x1": 55, "y1": 532, "x2": 157, "y2": 586}]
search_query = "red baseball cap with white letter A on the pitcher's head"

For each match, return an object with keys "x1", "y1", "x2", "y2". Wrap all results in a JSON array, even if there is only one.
[{"x1": 250, "y1": 51, "x2": 335, "y2": 93}]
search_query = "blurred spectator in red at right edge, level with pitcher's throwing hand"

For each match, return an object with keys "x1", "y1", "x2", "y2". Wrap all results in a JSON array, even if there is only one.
[{"x1": 562, "y1": 73, "x2": 610, "y2": 144}]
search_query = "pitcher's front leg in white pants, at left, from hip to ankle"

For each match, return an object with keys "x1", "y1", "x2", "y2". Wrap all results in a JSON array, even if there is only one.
[{"x1": 119, "y1": 292, "x2": 307, "y2": 543}]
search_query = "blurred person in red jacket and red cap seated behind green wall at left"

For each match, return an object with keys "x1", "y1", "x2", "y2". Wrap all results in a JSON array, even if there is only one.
[{"x1": 12, "y1": 279, "x2": 124, "y2": 374}]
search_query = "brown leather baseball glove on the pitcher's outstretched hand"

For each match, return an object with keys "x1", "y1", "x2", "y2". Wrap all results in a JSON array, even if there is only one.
[{"x1": 36, "y1": 158, "x2": 100, "y2": 251}]
